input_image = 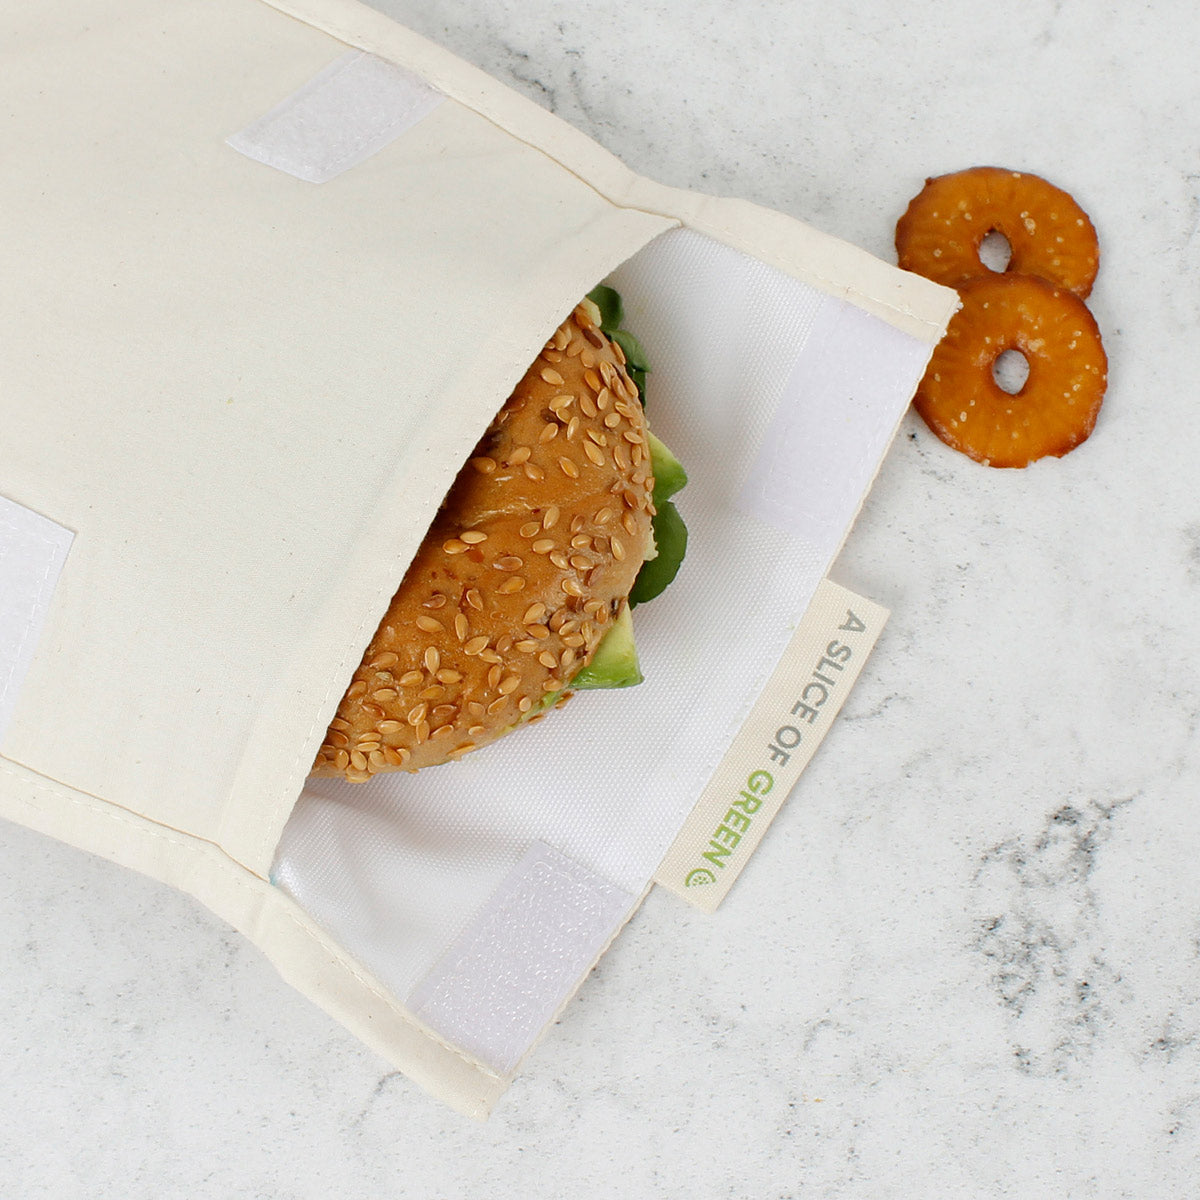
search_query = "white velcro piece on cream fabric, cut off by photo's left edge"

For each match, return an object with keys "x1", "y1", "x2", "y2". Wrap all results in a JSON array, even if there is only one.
[{"x1": 0, "y1": 496, "x2": 74, "y2": 742}]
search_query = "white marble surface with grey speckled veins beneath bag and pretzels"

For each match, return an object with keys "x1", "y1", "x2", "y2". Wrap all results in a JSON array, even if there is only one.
[{"x1": 0, "y1": 0, "x2": 1200, "y2": 1200}]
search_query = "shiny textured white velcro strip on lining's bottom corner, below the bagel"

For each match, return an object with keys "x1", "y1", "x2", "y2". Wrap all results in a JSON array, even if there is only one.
[{"x1": 408, "y1": 841, "x2": 636, "y2": 1075}]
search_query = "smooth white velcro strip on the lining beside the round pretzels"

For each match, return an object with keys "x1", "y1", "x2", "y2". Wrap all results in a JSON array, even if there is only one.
[{"x1": 739, "y1": 296, "x2": 929, "y2": 556}]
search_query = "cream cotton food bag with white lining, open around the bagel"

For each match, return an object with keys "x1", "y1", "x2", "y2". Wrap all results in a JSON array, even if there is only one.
[{"x1": 0, "y1": 0, "x2": 955, "y2": 1115}]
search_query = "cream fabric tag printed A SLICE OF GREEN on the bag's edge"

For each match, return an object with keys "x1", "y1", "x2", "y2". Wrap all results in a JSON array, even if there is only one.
[{"x1": 654, "y1": 580, "x2": 888, "y2": 912}]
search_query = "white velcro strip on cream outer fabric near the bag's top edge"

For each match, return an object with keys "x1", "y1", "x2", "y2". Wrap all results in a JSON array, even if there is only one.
[{"x1": 227, "y1": 50, "x2": 445, "y2": 184}]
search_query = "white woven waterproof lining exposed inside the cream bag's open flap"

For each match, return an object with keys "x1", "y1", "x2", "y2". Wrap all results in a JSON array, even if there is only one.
[{"x1": 272, "y1": 230, "x2": 928, "y2": 1060}]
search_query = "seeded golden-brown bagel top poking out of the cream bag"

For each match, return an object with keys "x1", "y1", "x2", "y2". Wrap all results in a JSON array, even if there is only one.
[{"x1": 313, "y1": 301, "x2": 654, "y2": 782}]
